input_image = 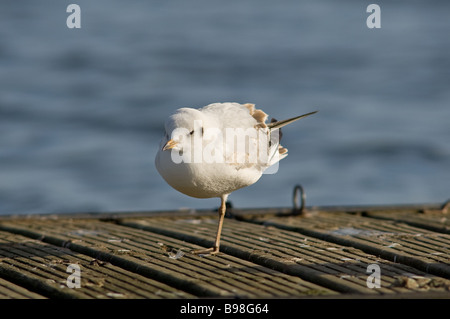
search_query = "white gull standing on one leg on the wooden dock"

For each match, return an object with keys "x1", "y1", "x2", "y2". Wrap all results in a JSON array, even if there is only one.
[{"x1": 155, "y1": 102, "x2": 317, "y2": 255}]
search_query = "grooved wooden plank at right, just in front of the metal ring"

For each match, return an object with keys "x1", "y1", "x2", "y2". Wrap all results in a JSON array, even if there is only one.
[{"x1": 236, "y1": 212, "x2": 450, "y2": 278}]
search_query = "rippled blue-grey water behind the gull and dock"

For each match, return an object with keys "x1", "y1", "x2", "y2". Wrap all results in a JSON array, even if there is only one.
[{"x1": 0, "y1": 0, "x2": 450, "y2": 214}]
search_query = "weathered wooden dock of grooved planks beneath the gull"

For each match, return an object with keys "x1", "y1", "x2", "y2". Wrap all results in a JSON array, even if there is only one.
[{"x1": 0, "y1": 204, "x2": 450, "y2": 299}]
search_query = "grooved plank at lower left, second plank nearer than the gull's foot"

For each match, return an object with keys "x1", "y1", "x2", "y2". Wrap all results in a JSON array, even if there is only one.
[{"x1": 0, "y1": 231, "x2": 193, "y2": 298}]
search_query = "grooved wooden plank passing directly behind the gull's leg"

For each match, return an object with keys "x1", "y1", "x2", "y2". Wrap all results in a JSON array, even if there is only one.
[{"x1": 116, "y1": 218, "x2": 450, "y2": 294}]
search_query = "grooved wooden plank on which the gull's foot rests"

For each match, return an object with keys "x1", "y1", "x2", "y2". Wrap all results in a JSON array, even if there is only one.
[{"x1": 0, "y1": 219, "x2": 333, "y2": 298}]
